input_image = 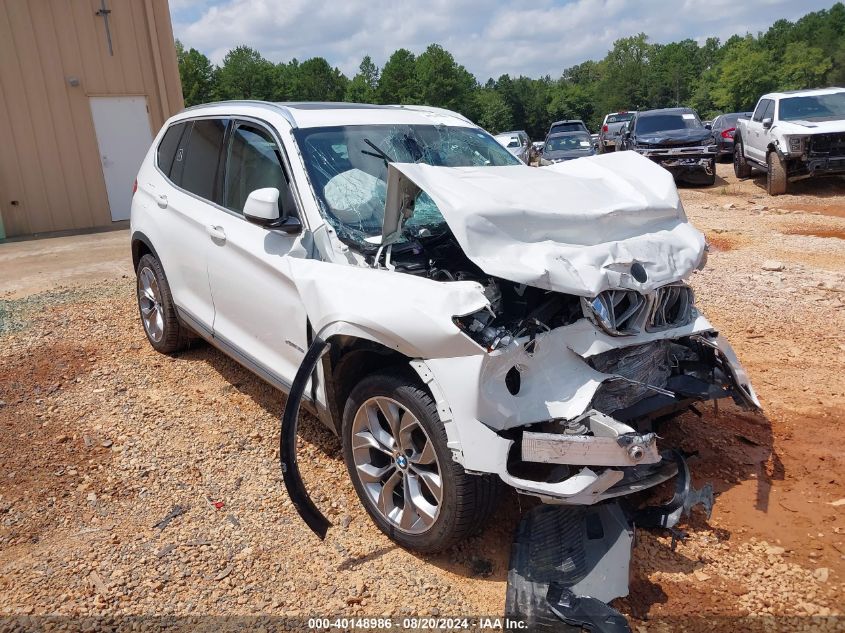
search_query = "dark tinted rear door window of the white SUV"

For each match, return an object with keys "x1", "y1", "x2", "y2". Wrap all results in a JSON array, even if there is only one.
[{"x1": 181, "y1": 119, "x2": 227, "y2": 202}]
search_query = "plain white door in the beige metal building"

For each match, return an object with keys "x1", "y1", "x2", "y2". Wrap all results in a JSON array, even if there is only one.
[{"x1": 90, "y1": 97, "x2": 153, "y2": 222}]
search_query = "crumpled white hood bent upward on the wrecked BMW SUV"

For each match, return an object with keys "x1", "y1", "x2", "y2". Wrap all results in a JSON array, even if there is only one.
[{"x1": 383, "y1": 152, "x2": 704, "y2": 297}]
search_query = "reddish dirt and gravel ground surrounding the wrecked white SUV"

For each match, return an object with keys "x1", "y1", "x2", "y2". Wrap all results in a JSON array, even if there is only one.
[{"x1": 0, "y1": 165, "x2": 845, "y2": 632}]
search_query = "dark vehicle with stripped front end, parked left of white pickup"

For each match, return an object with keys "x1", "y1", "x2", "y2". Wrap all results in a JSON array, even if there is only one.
[{"x1": 621, "y1": 108, "x2": 716, "y2": 185}]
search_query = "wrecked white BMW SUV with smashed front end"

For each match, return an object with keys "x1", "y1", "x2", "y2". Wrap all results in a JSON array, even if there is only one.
[{"x1": 131, "y1": 101, "x2": 759, "y2": 551}]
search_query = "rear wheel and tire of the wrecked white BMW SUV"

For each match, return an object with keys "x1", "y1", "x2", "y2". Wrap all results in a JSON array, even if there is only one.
[{"x1": 135, "y1": 254, "x2": 191, "y2": 354}]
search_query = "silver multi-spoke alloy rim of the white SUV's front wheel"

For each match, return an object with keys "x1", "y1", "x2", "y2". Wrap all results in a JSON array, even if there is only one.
[{"x1": 352, "y1": 396, "x2": 443, "y2": 534}]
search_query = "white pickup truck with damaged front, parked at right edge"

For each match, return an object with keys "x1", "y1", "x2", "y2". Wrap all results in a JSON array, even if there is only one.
[{"x1": 734, "y1": 88, "x2": 845, "y2": 196}]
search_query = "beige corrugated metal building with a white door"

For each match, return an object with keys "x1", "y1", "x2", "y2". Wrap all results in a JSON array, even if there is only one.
[{"x1": 0, "y1": 0, "x2": 183, "y2": 238}]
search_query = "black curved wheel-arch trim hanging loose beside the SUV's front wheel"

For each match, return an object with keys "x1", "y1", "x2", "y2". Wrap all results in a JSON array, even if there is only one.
[{"x1": 279, "y1": 336, "x2": 332, "y2": 539}]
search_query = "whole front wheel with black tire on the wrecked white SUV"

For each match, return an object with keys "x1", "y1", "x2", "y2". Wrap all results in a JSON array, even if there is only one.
[{"x1": 341, "y1": 373, "x2": 499, "y2": 553}]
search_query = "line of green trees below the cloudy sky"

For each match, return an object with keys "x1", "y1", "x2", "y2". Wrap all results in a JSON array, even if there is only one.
[{"x1": 176, "y1": 2, "x2": 845, "y2": 139}]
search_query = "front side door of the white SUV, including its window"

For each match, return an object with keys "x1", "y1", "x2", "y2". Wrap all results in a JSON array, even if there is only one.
[{"x1": 208, "y1": 121, "x2": 308, "y2": 386}]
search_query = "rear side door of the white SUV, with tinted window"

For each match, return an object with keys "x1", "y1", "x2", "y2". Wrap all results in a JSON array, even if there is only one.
[{"x1": 145, "y1": 119, "x2": 226, "y2": 332}]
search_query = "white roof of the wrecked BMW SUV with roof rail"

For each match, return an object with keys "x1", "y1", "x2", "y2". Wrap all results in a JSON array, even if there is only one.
[{"x1": 174, "y1": 100, "x2": 477, "y2": 128}]
